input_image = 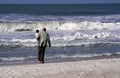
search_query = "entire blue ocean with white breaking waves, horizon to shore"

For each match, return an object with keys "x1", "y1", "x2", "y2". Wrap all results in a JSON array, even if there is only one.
[{"x1": 0, "y1": 4, "x2": 120, "y2": 65}]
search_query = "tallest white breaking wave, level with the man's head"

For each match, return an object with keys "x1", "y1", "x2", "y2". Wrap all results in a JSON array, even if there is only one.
[{"x1": 0, "y1": 21, "x2": 120, "y2": 32}]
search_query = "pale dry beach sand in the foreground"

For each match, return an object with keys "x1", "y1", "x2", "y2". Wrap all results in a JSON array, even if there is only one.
[{"x1": 0, "y1": 58, "x2": 120, "y2": 78}]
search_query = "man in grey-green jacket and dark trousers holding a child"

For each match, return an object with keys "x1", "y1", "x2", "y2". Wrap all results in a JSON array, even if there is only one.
[{"x1": 38, "y1": 28, "x2": 51, "y2": 63}]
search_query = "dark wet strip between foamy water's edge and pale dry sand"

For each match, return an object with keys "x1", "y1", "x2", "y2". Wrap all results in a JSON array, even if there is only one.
[{"x1": 0, "y1": 54, "x2": 120, "y2": 67}]
